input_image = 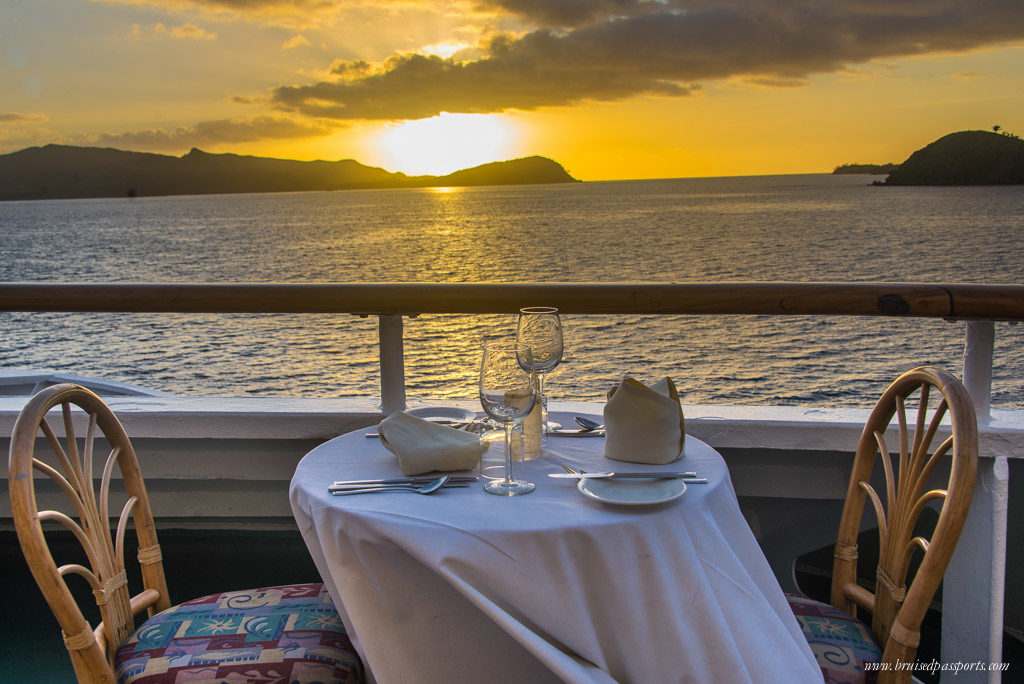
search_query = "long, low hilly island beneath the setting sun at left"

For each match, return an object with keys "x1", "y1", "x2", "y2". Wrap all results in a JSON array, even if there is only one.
[{"x1": 0, "y1": 144, "x2": 579, "y2": 201}]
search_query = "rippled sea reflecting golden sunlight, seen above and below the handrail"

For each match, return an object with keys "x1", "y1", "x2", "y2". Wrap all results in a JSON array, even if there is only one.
[{"x1": 0, "y1": 175, "x2": 1024, "y2": 409}]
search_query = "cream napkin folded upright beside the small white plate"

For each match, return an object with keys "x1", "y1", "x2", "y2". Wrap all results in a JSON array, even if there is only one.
[{"x1": 604, "y1": 378, "x2": 686, "y2": 465}]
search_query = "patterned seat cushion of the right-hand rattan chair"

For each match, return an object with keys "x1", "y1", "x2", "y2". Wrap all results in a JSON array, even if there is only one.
[{"x1": 785, "y1": 594, "x2": 882, "y2": 684}]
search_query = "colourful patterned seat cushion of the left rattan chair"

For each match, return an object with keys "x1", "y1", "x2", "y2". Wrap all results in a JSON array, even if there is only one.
[{"x1": 114, "y1": 584, "x2": 362, "y2": 684}]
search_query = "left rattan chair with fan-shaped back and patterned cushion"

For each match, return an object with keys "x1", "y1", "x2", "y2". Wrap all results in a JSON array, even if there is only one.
[{"x1": 8, "y1": 384, "x2": 362, "y2": 684}]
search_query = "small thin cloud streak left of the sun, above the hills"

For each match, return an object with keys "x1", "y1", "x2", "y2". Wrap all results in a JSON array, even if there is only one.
[{"x1": 89, "y1": 117, "x2": 333, "y2": 152}]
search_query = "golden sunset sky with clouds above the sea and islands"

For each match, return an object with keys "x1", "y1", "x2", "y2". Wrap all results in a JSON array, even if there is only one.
[{"x1": 0, "y1": 0, "x2": 1024, "y2": 180}]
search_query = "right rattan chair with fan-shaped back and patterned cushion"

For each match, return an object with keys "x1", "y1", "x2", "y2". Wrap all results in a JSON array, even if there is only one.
[{"x1": 790, "y1": 367, "x2": 978, "y2": 683}]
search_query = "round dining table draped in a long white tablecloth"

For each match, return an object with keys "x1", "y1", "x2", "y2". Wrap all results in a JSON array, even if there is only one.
[{"x1": 290, "y1": 413, "x2": 821, "y2": 684}]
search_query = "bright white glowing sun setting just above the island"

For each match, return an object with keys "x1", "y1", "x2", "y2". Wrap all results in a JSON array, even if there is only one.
[{"x1": 373, "y1": 112, "x2": 517, "y2": 175}]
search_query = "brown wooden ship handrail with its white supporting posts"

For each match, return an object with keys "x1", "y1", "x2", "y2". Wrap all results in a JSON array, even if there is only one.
[{"x1": 0, "y1": 282, "x2": 1024, "y2": 417}]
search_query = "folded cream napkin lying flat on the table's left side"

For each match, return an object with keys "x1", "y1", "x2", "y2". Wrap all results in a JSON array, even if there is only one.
[{"x1": 377, "y1": 412, "x2": 487, "y2": 475}]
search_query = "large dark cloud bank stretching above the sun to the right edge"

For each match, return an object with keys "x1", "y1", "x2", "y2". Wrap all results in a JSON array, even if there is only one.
[{"x1": 272, "y1": 0, "x2": 1024, "y2": 120}]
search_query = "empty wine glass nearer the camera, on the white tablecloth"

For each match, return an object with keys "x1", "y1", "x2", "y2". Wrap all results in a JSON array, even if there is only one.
[{"x1": 480, "y1": 341, "x2": 537, "y2": 497}]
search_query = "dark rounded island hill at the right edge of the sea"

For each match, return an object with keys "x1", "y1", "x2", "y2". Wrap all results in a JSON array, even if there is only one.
[{"x1": 876, "y1": 131, "x2": 1024, "y2": 185}]
